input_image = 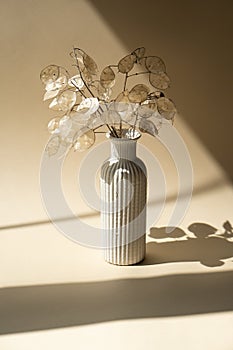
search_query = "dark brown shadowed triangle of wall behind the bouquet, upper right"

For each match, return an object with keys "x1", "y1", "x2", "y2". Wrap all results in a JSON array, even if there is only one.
[{"x1": 91, "y1": 0, "x2": 233, "y2": 178}]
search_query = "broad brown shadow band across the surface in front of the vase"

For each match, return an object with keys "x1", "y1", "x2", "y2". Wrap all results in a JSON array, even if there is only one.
[{"x1": 0, "y1": 271, "x2": 233, "y2": 334}]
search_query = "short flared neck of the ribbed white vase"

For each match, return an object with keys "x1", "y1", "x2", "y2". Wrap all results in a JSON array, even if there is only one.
[{"x1": 110, "y1": 139, "x2": 137, "y2": 160}]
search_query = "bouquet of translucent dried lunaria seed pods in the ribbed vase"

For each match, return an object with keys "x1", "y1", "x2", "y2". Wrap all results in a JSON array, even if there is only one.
[{"x1": 40, "y1": 47, "x2": 176, "y2": 155}]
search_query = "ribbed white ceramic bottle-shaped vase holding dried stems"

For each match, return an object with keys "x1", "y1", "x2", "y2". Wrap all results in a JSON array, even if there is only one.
[{"x1": 100, "y1": 137, "x2": 147, "y2": 265}]
